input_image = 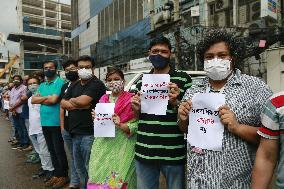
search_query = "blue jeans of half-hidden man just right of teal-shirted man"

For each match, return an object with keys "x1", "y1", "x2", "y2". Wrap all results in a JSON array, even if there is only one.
[{"x1": 61, "y1": 130, "x2": 80, "y2": 186}]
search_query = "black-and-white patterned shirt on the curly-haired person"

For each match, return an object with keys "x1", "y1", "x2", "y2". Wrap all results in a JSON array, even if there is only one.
[{"x1": 183, "y1": 70, "x2": 272, "y2": 189}]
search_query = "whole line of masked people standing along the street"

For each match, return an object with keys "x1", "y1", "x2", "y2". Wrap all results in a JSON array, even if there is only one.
[{"x1": 2, "y1": 30, "x2": 284, "y2": 189}]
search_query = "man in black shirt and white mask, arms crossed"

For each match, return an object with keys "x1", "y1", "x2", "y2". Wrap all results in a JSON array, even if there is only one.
[{"x1": 61, "y1": 56, "x2": 106, "y2": 189}]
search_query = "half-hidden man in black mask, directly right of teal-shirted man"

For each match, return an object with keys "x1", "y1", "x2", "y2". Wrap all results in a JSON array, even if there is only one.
[{"x1": 60, "y1": 59, "x2": 80, "y2": 189}]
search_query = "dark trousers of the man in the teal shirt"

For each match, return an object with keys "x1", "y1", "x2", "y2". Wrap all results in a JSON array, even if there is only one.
[{"x1": 42, "y1": 126, "x2": 68, "y2": 177}]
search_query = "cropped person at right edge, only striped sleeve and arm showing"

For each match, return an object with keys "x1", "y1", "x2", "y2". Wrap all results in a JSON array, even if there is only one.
[{"x1": 252, "y1": 92, "x2": 284, "y2": 189}]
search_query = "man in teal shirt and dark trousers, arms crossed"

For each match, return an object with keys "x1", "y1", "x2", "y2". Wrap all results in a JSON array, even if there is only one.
[{"x1": 31, "y1": 61, "x2": 69, "y2": 188}]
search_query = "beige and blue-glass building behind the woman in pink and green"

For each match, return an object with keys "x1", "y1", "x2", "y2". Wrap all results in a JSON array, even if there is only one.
[{"x1": 71, "y1": 0, "x2": 150, "y2": 77}]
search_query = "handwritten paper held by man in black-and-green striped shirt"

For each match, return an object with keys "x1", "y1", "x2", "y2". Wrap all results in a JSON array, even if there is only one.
[{"x1": 141, "y1": 74, "x2": 170, "y2": 115}]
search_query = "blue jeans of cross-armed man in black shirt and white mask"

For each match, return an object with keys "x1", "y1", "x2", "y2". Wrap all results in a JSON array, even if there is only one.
[{"x1": 72, "y1": 134, "x2": 94, "y2": 189}]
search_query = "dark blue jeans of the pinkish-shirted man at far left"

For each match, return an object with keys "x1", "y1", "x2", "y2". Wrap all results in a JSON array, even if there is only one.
[{"x1": 13, "y1": 113, "x2": 29, "y2": 145}]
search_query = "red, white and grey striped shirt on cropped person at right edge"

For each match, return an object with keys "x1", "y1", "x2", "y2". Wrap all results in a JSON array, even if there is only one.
[{"x1": 257, "y1": 91, "x2": 284, "y2": 188}]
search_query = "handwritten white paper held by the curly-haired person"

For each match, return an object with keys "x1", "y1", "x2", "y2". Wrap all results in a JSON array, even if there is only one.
[{"x1": 187, "y1": 93, "x2": 225, "y2": 151}]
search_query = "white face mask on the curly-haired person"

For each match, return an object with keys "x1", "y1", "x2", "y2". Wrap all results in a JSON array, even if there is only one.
[{"x1": 204, "y1": 58, "x2": 232, "y2": 81}]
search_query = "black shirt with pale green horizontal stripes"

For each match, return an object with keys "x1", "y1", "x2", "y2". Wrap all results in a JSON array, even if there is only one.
[{"x1": 135, "y1": 68, "x2": 192, "y2": 165}]
